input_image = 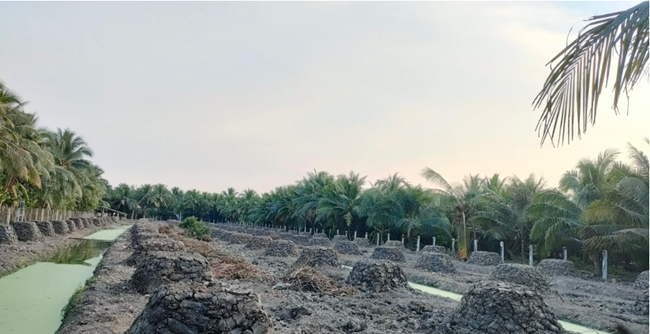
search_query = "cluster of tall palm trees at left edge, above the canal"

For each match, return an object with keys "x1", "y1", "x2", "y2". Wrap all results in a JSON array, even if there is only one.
[{"x1": 0, "y1": 82, "x2": 108, "y2": 212}]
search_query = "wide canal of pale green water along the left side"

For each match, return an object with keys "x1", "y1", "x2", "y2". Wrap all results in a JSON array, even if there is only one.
[{"x1": 0, "y1": 227, "x2": 127, "y2": 334}]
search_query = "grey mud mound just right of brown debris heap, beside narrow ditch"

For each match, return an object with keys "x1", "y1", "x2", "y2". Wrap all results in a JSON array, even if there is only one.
[{"x1": 346, "y1": 260, "x2": 408, "y2": 292}]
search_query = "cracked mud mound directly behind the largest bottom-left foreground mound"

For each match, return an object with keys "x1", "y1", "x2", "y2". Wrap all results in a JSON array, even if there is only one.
[{"x1": 131, "y1": 252, "x2": 212, "y2": 294}]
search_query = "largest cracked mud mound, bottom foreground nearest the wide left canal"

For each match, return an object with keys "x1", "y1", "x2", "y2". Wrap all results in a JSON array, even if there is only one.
[{"x1": 127, "y1": 284, "x2": 275, "y2": 334}]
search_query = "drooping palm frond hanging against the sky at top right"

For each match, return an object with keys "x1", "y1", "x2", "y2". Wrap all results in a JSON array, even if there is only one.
[{"x1": 533, "y1": 1, "x2": 648, "y2": 145}]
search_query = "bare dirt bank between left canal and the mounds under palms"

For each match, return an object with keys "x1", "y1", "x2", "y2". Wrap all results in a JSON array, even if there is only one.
[{"x1": 0, "y1": 225, "x2": 122, "y2": 277}]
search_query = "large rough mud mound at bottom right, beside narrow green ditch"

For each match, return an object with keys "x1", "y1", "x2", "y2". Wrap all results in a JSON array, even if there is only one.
[{"x1": 442, "y1": 281, "x2": 563, "y2": 334}]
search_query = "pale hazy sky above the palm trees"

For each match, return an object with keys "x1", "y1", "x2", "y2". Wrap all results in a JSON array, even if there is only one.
[{"x1": 0, "y1": 2, "x2": 650, "y2": 192}]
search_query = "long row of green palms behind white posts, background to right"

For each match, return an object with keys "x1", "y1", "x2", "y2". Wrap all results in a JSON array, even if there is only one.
[{"x1": 105, "y1": 142, "x2": 648, "y2": 267}]
